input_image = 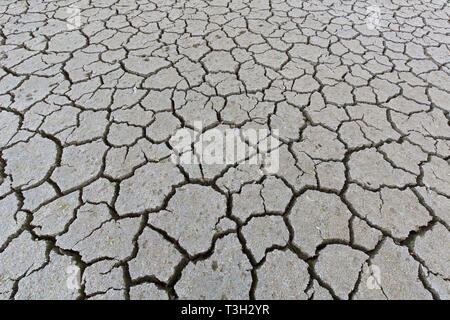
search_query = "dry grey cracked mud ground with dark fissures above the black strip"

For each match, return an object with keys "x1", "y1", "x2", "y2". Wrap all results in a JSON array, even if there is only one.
[{"x1": 0, "y1": 0, "x2": 450, "y2": 299}]
